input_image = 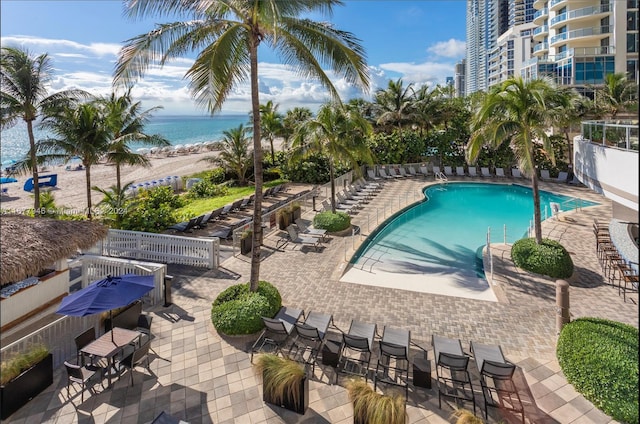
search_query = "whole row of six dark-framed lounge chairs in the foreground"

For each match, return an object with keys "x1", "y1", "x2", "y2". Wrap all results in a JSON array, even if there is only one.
[{"x1": 251, "y1": 307, "x2": 525, "y2": 422}]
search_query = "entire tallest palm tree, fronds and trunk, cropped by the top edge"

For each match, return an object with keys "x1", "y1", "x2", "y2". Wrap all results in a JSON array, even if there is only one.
[{"x1": 115, "y1": 0, "x2": 369, "y2": 291}]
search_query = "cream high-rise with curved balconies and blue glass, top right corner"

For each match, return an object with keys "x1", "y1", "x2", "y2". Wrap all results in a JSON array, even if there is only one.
[{"x1": 521, "y1": 0, "x2": 639, "y2": 91}]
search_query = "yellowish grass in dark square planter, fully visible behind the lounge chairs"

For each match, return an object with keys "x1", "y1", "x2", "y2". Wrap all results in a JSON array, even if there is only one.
[{"x1": 256, "y1": 353, "x2": 309, "y2": 415}]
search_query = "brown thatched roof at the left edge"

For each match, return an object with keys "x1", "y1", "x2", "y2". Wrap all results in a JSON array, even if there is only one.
[{"x1": 0, "y1": 215, "x2": 108, "y2": 284}]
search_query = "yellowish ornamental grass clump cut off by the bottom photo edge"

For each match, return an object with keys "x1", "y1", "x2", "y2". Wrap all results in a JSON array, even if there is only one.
[{"x1": 346, "y1": 379, "x2": 407, "y2": 424}]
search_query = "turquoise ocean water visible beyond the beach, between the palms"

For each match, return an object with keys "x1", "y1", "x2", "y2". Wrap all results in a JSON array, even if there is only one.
[{"x1": 0, "y1": 114, "x2": 249, "y2": 165}]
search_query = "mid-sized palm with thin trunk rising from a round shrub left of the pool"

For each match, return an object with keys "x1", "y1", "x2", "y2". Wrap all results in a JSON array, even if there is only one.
[{"x1": 290, "y1": 103, "x2": 373, "y2": 213}]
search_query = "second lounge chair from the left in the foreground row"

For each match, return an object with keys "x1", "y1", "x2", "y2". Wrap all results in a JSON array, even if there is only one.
[{"x1": 289, "y1": 311, "x2": 333, "y2": 373}]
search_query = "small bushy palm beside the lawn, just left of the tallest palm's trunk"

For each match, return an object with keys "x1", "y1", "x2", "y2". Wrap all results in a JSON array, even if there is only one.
[{"x1": 202, "y1": 124, "x2": 253, "y2": 185}]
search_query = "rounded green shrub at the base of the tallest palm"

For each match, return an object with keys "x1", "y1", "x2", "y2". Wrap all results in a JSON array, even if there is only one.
[{"x1": 211, "y1": 281, "x2": 282, "y2": 335}]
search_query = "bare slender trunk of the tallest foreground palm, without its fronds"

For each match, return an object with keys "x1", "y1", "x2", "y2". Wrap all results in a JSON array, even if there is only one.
[{"x1": 249, "y1": 34, "x2": 263, "y2": 291}]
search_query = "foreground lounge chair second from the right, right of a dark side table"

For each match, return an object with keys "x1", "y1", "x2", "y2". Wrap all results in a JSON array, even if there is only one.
[{"x1": 431, "y1": 334, "x2": 476, "y2": 414}]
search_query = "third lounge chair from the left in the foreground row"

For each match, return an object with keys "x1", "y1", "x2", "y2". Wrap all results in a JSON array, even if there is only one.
[{"x1": 336, "y1": 320, "x2": 376, "y2": 383}]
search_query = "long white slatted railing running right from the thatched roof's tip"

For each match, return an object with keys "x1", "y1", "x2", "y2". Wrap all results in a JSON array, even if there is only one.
[{"x1": 94, "y1": 230, "x2": 220, "y2": 269}]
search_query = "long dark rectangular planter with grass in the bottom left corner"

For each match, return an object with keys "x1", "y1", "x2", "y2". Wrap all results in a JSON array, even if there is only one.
[{"x1": 0, "y1": 344, "x2": 53, "y2": 420}]
